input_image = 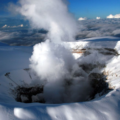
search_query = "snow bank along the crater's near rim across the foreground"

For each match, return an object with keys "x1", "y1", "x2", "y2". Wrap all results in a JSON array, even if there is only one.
[{"x1": 0, "y1": 89, "x2": 120, "y2": 120}]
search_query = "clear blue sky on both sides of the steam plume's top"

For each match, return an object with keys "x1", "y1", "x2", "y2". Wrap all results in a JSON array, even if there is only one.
[{"x1": 0, "y1": 0, "x2": 120, "y2": 18}]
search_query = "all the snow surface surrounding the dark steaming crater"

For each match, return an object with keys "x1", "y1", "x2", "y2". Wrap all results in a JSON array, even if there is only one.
[{"x1": 0, "y1": 37, "x2": 120, "y2": 120}]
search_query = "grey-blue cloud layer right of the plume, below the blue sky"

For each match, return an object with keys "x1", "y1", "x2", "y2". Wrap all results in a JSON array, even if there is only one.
[{"x1": 76, "y1": 19, "x2": 120, "y2": 39}]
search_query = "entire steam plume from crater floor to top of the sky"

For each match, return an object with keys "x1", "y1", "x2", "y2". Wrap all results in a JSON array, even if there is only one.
[{"x1": 11, "y1": 0, "x2": 92, "y2": 103}]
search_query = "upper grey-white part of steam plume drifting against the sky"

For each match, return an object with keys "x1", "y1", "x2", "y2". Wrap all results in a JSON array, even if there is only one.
[{"x1": 15, "y1": 0, "x2": 78, "y2": 42}]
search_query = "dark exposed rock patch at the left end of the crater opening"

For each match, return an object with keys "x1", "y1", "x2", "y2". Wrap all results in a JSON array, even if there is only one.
[{"x1": 14, "y1": 86, "x2": 45, "y2": 103}]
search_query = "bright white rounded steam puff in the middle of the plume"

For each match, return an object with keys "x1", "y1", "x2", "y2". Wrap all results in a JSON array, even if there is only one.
[{"x1": 30, "y1": 41, "x2": 76, "y2": 81}]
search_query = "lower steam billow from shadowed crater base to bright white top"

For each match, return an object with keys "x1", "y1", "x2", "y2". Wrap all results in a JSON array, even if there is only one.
[{"x1": 30, "y1": 41, "x2": 90, "y2": 103}]
